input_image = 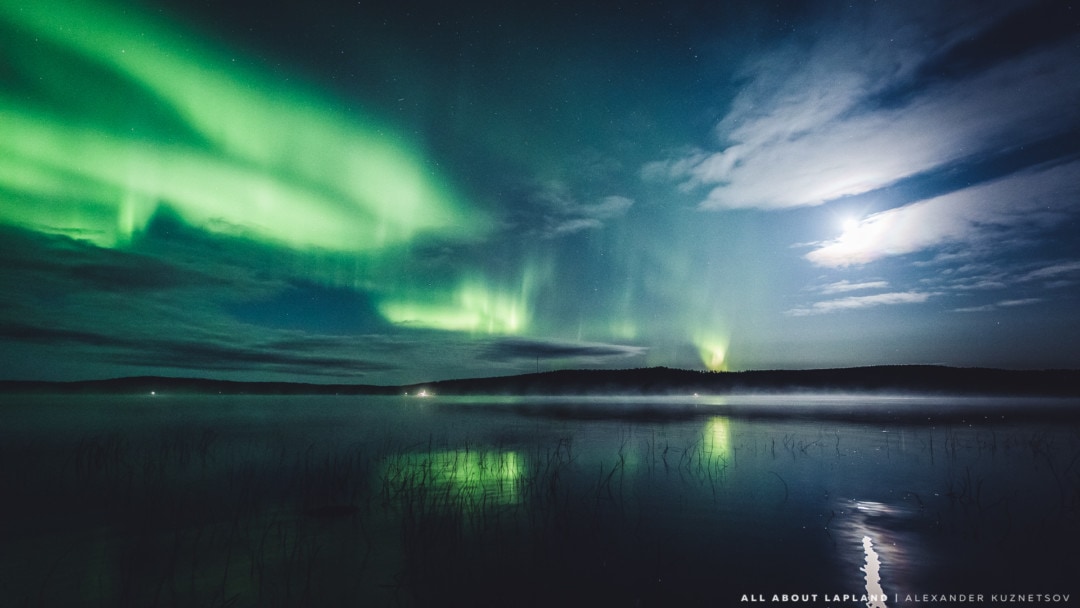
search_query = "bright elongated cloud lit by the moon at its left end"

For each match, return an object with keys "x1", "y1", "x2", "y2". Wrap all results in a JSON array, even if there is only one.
[{"x1": 804, "y1": 162, "x2": 1080, "y2": 268}]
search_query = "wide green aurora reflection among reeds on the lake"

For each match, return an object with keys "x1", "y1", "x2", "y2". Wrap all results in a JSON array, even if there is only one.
[{"x1": 384, "y1": 448, "x2": 525, "y2": 509}]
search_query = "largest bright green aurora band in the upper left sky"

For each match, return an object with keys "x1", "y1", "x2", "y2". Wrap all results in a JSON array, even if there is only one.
[{"x1": 0, "y1": 0, "x2": 486, "y2": 252}]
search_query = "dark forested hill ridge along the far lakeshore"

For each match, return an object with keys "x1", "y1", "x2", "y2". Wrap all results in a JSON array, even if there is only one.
[{"x1": 6, "y1": 365, "x2": 1080, "y2": 396}]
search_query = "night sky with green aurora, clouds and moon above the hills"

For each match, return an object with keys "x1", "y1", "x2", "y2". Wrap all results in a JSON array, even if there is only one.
[{"x1": 0, "y1": 0, "x2": 1080, "y2": 384}]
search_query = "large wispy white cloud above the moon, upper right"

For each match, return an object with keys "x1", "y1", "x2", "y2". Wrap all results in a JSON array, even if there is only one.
[{"x1": 645, "y1": 1, "x2": 1080, "y2": 208}]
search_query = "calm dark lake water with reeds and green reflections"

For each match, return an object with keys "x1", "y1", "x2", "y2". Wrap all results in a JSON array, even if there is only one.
[{"x1": 0, "y1": 395, "x2": 1080, "y2": 608}]
